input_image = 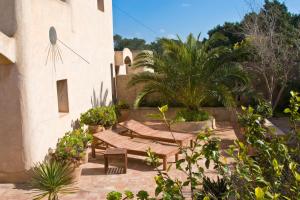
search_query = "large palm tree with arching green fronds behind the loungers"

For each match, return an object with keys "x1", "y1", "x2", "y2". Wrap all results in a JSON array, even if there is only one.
[{"x1": 129, "y1": 34, "x2": 248, "y2": 110}]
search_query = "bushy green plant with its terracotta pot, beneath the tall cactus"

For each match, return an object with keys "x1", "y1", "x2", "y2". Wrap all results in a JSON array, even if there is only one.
[{"x1": 80, "y1": 106, "x2": 117, "y2": 157}]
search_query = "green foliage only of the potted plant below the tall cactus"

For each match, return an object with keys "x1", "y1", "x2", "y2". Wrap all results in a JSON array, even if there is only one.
[{"x1": 80, "y1": 106, "x2": 117, "y2": 127}]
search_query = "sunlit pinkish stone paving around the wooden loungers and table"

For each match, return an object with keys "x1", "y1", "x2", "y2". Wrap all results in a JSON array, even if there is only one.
[{"x1": 0, "y1": 123, "x2": 236, "y2": 200}]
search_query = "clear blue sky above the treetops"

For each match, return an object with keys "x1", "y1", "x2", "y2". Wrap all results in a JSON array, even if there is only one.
[{"x1": 113, "y1": 0, "x2": 300, "y2": 42}]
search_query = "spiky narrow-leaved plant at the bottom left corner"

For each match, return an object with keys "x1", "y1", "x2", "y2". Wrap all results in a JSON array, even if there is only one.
[{"x1": 31, "y1": 161, "x2": 76, "y2": 200}]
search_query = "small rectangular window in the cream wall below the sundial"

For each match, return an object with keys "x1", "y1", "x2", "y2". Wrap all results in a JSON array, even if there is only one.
[{"x1": 56, "y1": 79, "x2": 69, "y2": 113}]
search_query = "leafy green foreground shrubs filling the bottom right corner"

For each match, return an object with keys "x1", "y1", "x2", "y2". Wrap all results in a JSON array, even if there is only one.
[{"x1": 105, "y1": 92, "x2": 300, "y2": 200}]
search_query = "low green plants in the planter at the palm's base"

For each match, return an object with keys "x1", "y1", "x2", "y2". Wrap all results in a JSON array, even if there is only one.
[{"x1": 176, "y1": 109, "x2": 209, "y2": 122}]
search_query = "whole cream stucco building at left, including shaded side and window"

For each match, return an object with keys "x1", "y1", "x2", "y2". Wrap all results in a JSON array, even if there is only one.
[{"x1": 0, "y1": 0, "x2": 114, "y2": 182}]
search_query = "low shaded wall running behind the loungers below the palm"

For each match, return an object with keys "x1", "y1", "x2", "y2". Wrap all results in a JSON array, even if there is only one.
[{"x1": 129, "y1": 107, "x2": 234, "y2": 121}]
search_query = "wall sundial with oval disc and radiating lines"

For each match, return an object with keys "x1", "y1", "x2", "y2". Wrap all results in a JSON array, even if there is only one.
[{"x1": 46, "y1": 26, "x2": 90, "y2": 67}]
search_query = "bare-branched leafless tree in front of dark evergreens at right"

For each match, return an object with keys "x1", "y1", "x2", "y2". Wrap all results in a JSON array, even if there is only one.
[{"x1": 242, "y1": 0, "x2": 300, "y2": 110}]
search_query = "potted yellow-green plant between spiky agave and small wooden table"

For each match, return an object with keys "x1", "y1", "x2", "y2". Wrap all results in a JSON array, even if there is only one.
[{"x1": 53, "y1": 129, "x2": 93, "y2": 181}]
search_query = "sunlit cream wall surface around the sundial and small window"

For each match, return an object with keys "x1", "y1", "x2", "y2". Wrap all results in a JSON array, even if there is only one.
[{"x1": 0, "y1": 0, "x2": 114, "y2": 181}]
